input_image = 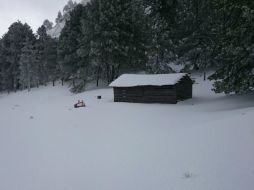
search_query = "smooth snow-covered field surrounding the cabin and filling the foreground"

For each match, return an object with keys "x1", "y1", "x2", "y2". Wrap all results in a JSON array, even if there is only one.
[{"x1": 0, "y1": 74, "x2": 254, "y2": 190}]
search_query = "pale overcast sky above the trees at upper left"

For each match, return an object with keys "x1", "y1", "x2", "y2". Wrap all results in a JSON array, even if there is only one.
[{"x1": 0, "y1": 0, "x2": 80, "y2": 37}]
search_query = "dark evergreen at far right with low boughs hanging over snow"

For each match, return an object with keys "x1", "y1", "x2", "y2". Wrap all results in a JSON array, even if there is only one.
[{"x1": 210, "y1": 0, "x2": 254, "y2": 93}]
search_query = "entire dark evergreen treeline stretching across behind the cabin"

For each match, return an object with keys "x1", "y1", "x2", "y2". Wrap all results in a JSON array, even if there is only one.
[{"x1": 0, "y1": 0, "x2": 254, "y2": 93}]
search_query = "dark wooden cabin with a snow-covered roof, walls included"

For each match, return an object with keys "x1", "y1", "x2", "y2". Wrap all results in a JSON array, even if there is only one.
[{"x1": 110, "y1": 73, "x2": 192, "y2": 104}]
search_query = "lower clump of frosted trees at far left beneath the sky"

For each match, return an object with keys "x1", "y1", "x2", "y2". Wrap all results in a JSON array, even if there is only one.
[{"x1": 0, "y1": 22, "x2": 59, "y2": 92}]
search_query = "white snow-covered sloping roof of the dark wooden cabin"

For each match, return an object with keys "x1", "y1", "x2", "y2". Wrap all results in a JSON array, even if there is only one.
[{"x1": 109, "y1": 73, "x2": 188, "y2": 87}]
